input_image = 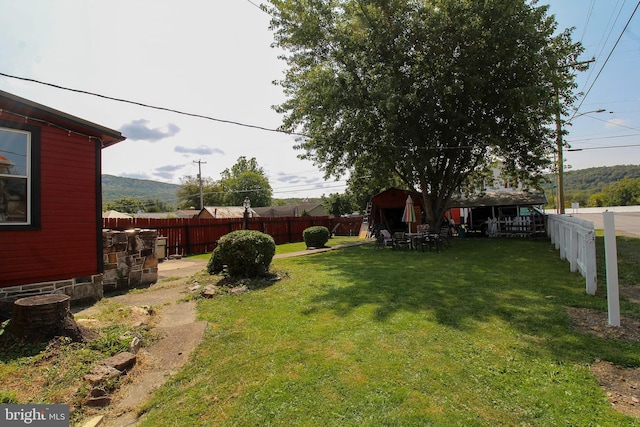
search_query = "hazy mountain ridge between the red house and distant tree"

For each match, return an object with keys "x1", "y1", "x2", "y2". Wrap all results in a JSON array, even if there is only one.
[{"x1": 102, "y1": 175, "x2": 180, "y2": 205}]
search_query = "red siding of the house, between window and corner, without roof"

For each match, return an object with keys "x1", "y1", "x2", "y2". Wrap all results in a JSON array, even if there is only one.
[{"x1": 0, "y1": 118, "x2": 100, "y2": 287}]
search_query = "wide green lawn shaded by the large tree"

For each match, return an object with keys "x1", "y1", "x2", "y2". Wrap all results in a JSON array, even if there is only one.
[{"x1": 140, "y1": 238, "x2": 640, "y2": 426}]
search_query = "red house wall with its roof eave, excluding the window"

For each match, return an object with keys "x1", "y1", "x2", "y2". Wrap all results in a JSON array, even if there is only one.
[{"x1": 0, "y1": 91, "x2": 125, "y2": 288}]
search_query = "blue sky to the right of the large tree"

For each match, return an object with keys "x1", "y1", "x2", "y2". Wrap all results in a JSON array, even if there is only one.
[{"x1": 539, "y1": 0, "x2": 640, "y2": 174}]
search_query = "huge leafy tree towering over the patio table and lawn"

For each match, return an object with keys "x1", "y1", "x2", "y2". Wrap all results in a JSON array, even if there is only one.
[{"x1": 265, "y1": 0, "x2": 582, "y2": 229}]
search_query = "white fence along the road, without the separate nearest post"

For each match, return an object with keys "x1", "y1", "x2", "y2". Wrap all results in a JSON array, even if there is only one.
[{"x1": 547, "y1": 215, "x2": 597, "y2": 295}]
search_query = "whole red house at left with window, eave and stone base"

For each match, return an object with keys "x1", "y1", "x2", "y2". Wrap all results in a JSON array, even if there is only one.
[{"x1": 0, "y1": 91, "x2": 125, "y2": 308}]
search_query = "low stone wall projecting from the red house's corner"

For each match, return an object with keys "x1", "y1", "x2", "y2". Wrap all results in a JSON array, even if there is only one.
[{"x1": 102, "y1": 228, "x2": 158, "y2": 290}]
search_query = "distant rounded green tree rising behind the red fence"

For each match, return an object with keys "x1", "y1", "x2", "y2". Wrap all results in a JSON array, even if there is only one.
[{"x1": 220, "y1": 156, "x2": 273, "y2": 206}]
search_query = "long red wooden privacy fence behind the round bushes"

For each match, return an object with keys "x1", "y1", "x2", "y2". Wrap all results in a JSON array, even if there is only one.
[{"x1": 102, "y1": 216, "x2": 362, "y2": 256}]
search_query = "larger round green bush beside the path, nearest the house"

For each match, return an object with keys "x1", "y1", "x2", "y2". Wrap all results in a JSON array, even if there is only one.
[{"x1": 214, "y1": 230, "x2": 276, "y2": 278}]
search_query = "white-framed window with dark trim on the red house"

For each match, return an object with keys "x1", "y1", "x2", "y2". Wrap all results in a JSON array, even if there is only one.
[{"x1": 0, "y1": 124, "x2": 39, "y2": 228}]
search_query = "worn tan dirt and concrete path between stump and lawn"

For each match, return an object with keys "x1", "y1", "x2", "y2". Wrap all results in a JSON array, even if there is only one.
[{"x1": 75, "y1": 260, "x2": 207, "y2": 427}]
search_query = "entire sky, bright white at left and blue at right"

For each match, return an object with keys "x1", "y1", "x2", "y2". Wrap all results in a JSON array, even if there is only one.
[{"x1": 0, "y1": 0, "x2": 640, "y2": 198}]
